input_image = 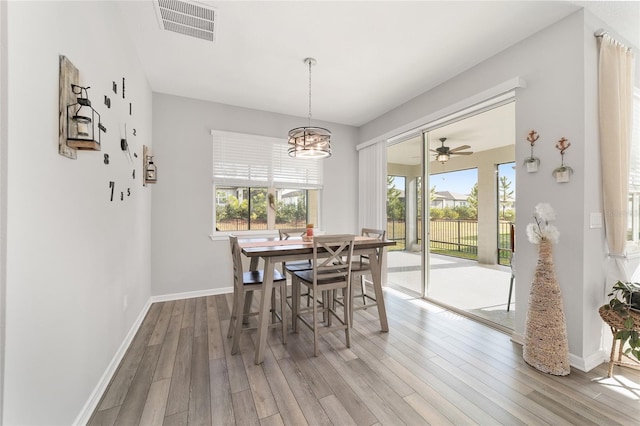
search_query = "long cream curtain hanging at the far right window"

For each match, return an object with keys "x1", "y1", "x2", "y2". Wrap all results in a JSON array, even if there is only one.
[{"x1": 598, "y1": 34, "x2": 634, "y2": 284}]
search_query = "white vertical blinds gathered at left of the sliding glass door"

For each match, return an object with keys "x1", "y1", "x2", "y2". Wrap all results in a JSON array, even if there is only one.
[{"x1": 358, "y1": 141, "x2": 387, "y2": 229}]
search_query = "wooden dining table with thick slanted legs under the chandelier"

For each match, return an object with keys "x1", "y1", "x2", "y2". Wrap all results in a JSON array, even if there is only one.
[{"x1": 239, "y1": 236, "x2": 395, "y2": 364}]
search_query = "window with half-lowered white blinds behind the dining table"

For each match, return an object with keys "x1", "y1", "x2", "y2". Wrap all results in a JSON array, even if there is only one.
[{"x1": 211, "y1": 130, "x2": 322, "y2": 232}]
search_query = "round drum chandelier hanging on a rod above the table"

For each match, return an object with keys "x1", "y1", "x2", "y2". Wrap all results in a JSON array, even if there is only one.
[{"x1": 289, "y1": 58, "x2": 331, "y2": 158}]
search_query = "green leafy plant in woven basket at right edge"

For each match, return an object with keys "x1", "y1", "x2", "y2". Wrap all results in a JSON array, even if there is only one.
[{"x1": 600, "y1": 281, "x2": 640, "y2": 361}]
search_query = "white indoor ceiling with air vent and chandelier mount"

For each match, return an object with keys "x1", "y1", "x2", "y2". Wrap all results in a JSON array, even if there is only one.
[{"x1": 120, "y1": 0, "x2": 640, "y2": 126}]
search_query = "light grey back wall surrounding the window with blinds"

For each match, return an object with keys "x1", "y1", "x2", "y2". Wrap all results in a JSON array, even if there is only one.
[{"x1": 151, "y1": 93, "x2": 359, "y2": 295}]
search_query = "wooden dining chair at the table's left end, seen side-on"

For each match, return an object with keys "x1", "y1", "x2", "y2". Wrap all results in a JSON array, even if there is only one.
[{"x1": 227, "y1": 235, "x2": 287, "y2": 355}]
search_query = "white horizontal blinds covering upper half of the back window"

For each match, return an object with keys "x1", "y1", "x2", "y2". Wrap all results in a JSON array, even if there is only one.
[{"x1": 211, "y1": 130, "x2": 322, "y2": 189}]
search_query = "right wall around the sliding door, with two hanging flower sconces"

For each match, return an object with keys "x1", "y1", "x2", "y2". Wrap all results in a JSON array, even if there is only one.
[{"x1": 360, "y1": 11, "x2": 608, "y2": 369}]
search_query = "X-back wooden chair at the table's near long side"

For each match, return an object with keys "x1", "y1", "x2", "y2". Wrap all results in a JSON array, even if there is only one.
[{"x1": 292, "y1": 235, "x2": 355, "y2": 356}]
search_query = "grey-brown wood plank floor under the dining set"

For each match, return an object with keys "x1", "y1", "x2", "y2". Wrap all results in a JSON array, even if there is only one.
[{"x1": 89, "y1": 291, "x2": 640, "y2": 425}]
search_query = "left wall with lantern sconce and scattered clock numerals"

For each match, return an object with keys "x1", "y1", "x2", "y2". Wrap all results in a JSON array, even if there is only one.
[{"x1": 2, "y1": 1, "x2": 152, "y2": 425}]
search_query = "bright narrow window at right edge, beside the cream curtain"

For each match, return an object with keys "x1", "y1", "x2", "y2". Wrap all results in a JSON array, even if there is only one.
[{"x1": 627, "y1": 88, "x2": 640, "y2": 243}]
